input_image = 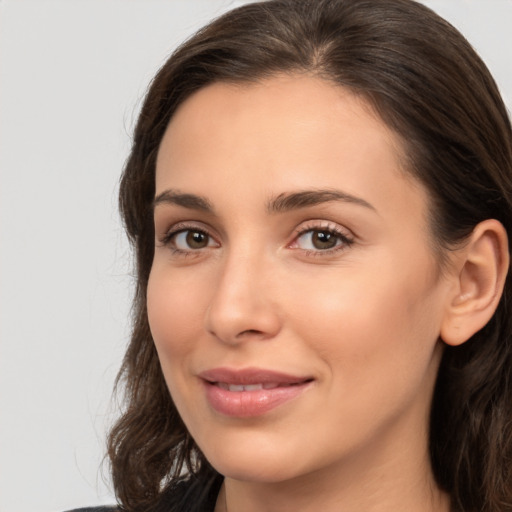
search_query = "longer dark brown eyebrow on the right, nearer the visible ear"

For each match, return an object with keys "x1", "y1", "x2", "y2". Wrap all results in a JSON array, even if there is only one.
[{"x1": 267, "y1": 189, "x2": 377, "y2": 213}]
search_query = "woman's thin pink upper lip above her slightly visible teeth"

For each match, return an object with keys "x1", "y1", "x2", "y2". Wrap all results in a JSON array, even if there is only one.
[{"x1": 199, "y1": 368, "x2": 313, "y2": 385}]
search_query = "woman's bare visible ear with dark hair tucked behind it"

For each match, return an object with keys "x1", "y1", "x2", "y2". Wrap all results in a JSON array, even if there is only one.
[{"x1": 440, "y1": 219, "x2": 509, "y2": 345}]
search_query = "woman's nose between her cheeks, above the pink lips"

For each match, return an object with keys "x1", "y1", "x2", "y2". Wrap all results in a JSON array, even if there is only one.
[{"x1": 205, "y1": 254, "x2": 281, "y2": 344}]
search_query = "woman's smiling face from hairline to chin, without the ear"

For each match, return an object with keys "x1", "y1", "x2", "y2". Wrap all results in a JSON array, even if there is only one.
[{"x1": 147, "y1": 76, "x2": 447, "y2": 482}]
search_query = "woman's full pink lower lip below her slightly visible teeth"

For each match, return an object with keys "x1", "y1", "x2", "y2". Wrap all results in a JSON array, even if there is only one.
[{"x1": 205, "y1": 381, "x2": 311, "y2": 418}]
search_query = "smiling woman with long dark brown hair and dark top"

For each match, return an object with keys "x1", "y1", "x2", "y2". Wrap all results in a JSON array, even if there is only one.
[{"x1": 76, "y1": 0, "x2": 512, "y2": 512}]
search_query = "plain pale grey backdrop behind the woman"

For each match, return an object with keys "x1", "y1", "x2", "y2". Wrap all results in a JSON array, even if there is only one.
[{"x1": 0, "y1": 0, "x2": 512, "y2": 512}]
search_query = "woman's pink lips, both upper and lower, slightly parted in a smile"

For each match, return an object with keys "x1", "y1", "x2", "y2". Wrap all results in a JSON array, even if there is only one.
[{"x1": 199, "y1": 368, "x2": 313, "y2": 418}]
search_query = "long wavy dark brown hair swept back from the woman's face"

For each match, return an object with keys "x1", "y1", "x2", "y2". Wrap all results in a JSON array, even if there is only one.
[{"x1": 108, "y1": 0, "x2": 512, "y2": 512}]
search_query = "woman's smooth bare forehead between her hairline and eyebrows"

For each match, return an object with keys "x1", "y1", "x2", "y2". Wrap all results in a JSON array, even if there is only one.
[{"x1": 156, "y1": 75, "x2": 425, "y2": 222}]
